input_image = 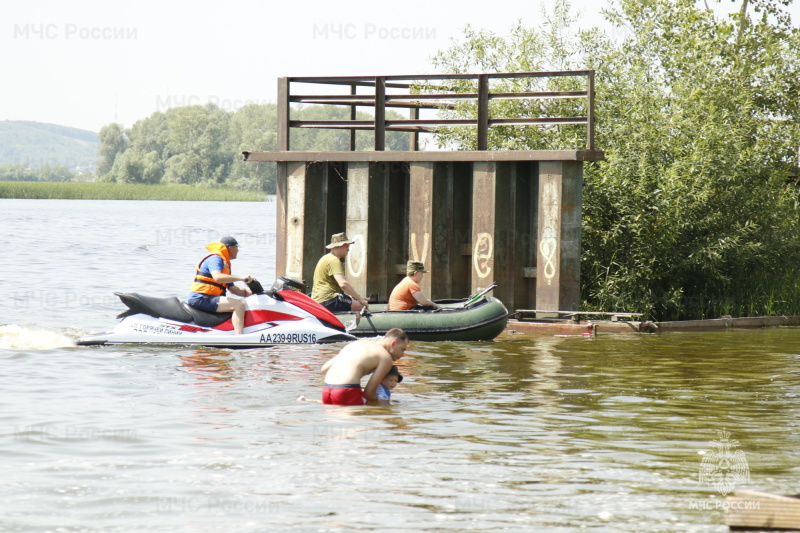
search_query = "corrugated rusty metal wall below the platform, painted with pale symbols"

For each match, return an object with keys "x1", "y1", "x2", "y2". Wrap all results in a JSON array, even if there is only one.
[{"x1": 276, "y1": 157, "x2": 583, "y2": 310}]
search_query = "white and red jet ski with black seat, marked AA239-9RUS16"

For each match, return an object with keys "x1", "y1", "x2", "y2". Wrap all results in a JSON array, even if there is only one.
[{"x1": 77, "y1": 277, "x2": 355, "y2": 348}]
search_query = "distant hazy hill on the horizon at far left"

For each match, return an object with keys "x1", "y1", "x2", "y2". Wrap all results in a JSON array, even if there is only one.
[{"x1": 0, "y1": 120, "x2": 99, "y2": 170}]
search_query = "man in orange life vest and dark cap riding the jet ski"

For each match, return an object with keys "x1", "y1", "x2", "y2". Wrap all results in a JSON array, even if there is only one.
[{"x1": 187, "y1": 237, "x2": 255, "y2": 335}]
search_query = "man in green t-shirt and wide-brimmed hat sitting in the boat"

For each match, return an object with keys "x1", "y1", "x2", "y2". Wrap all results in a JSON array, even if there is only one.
[{"x1": 311, "y1": 233, "x2": 369, "y2": 313}]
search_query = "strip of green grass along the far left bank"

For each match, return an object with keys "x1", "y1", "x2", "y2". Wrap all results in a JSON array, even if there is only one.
[{"x1": 0, "y1": 181, "x2": 266, "y2": 202}]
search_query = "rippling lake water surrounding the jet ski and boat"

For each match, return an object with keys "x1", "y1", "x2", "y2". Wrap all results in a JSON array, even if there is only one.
[{"x1": 0, "y1": 200, "x2": 800, "y2": 533}]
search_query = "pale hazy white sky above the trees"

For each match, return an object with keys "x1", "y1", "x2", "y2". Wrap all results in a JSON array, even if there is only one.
[{"x1": 0, "y1": 0, "x2": 800, "y2": 131}]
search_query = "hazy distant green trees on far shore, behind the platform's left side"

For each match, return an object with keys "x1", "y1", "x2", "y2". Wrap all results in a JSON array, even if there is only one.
[{"x1": 94, "y1": 96, "x2": 408, "y2": 193}]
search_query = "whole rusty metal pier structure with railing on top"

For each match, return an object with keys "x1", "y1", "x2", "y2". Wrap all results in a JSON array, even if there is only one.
[{"x1": 245, "y1": 71, "x2": 603, "y2": 311}]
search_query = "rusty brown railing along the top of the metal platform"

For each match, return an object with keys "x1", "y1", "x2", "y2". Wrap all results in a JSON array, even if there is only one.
[{"x1": 278, "y1": 70, "x2": 594, "y2": 151}]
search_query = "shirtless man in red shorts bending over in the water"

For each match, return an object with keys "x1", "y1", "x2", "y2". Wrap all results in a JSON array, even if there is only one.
[{"x1": 322, "y1": 328, "x2": 408, "y2": 405}]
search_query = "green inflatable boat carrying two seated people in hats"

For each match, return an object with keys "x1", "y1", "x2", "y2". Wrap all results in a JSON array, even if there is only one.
[{"x1": 336, "y1": 286, "x2": 509, "y2": 342}]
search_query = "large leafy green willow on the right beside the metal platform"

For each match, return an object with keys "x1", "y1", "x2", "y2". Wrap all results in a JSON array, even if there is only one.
[{"x1": 434, "y1": 0, "x2": 800, "y2": 319}]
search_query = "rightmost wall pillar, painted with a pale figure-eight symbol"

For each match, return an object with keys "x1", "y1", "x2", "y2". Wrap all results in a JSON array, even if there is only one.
[{"x1": 536, "y1": 161, "x2": 583, "y2": 311}]
